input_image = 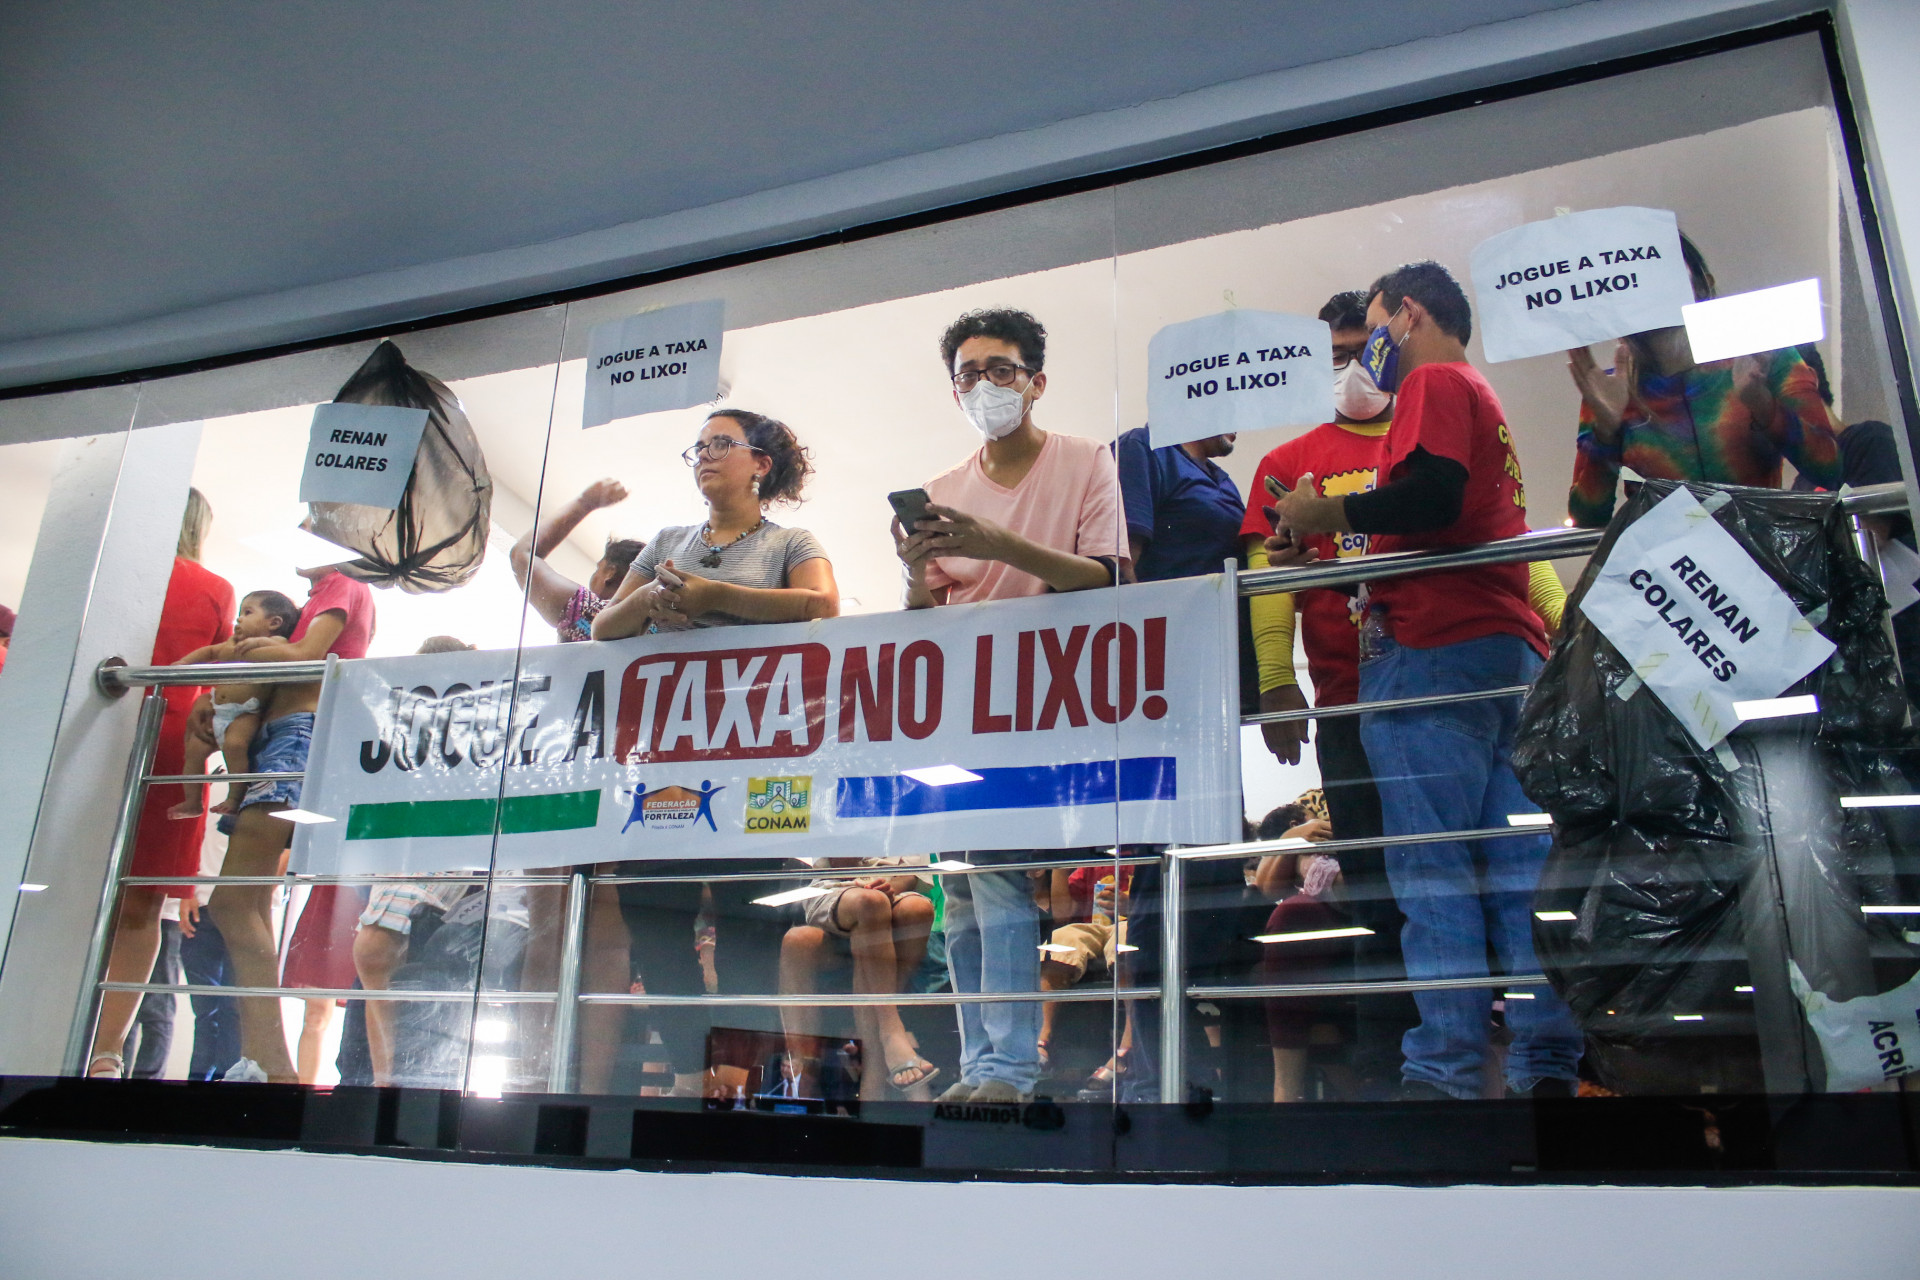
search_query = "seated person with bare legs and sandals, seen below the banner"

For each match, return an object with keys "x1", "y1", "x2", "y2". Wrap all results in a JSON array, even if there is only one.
[{"x1": 780, "y1": 858, "x2": 939, "y2": 1100}]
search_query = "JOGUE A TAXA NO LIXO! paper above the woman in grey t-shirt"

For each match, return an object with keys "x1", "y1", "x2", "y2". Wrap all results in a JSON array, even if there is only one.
[{"x1": 580, "y1": 299, "x2": 726, "y2": 428}]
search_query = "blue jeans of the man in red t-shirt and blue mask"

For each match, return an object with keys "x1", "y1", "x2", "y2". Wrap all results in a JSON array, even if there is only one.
[{"x1": 1359, "y1": 635, "x2": 1584, "y2": 1098}]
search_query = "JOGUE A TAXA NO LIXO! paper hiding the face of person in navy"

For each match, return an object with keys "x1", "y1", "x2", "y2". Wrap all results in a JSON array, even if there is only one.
[{"x1": 1146, "y1": 309, "x2": 1332, "y2": 449}]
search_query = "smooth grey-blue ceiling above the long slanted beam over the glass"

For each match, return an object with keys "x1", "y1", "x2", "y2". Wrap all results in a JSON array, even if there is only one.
[{"x1": 0, "y1": 0, "x2": 1572, "y2": 385}]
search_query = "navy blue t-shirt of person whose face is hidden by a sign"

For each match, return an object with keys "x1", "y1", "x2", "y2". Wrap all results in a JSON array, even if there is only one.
[{"x1": 1114, "y1": 426, "x2": 1246, "y2": 581}]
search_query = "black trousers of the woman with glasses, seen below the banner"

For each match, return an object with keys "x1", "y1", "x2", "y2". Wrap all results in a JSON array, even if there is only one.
[{"x1": 618, "y1": 858, "x2": 803, "y2": 1075}]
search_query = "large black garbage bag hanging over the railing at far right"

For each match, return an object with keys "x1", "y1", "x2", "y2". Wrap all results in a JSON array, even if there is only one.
[{"x1": 1513, "y1": 482, "x2": 1914, "y2": 1092}]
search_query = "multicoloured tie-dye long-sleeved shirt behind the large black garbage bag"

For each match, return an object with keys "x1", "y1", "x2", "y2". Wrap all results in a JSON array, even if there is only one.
[{"x1": 1567, "y1": 347, "x2": 1839, "y2": 528}]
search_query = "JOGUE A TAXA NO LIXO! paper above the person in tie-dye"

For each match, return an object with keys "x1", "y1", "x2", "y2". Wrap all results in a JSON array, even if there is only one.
[{"x1": 1473, "y1": 205, "x2": 1693, "y2": 365}]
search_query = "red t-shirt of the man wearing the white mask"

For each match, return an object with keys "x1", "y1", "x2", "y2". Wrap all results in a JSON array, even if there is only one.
[{"x1": 1240, "y1": 422, "x2": 1386, "y2": 706}]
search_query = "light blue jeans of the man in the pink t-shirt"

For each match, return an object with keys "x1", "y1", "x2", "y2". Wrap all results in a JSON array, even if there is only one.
[{"x1": 941, "y1": 854, "x2": 1041, "y2": 1094}]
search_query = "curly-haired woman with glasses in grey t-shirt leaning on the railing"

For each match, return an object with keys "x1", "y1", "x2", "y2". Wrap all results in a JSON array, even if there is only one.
[{"x1": 582, "y1": 409, "x2": 839, "y2": 1096}]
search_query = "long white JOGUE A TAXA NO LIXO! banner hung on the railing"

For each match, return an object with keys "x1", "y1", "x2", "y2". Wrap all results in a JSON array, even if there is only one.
[{"x1": 292, "y1": 576, "x2": 1240, "y2": 875}]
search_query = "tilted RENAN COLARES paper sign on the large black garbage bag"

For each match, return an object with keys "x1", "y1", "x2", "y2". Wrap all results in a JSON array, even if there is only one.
[{"x1": 1580, "y1": 489, "x2": 1834, "y2": 747}]
